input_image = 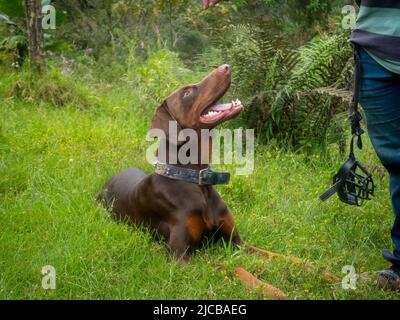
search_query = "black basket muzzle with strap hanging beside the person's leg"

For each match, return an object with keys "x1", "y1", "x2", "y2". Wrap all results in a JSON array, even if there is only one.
[{"x1": 320, "y1": 44, "x2": 375, "y2": 207}]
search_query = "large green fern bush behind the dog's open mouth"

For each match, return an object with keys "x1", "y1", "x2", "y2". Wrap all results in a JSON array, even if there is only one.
[{"x1": 219, "y1": 25, "x2": 351, "y2": 149}]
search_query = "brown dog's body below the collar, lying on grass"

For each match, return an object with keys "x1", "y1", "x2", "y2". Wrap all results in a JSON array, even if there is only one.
[{"x1": 103, "y1": 169, "x2": 240, "y2": 257}]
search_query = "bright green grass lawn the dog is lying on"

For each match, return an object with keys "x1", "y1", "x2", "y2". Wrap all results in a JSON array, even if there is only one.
[{"x1": 0, "y1": 67, "x2": 399, "y2": 299}]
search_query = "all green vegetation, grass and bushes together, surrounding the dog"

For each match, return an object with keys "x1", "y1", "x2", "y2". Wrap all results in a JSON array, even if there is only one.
[{"x1": 0, "y1": 0, "x2": 398, "y2": 299}]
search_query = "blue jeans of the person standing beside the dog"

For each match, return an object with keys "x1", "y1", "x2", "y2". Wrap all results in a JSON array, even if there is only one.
[{"x1": 360, "y1": 49, "x2": 400, "y2": 267}]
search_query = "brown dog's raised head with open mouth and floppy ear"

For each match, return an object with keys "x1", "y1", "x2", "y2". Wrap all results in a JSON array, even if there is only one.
[{"x1": 152, "y1": 64, "x2": 243, "y2": 136}]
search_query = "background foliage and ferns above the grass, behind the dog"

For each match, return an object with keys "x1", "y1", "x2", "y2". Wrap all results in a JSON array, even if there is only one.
[{"x1": 0, "y1": 0, "x2": 352, "y2": 150}]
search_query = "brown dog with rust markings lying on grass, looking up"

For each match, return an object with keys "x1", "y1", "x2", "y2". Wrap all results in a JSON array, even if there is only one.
[{"x1": 100, "y1": 64, "x2": 242, "y2": 257}]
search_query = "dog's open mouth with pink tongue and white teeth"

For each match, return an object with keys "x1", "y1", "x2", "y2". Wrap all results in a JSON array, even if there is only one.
[{"x1": 200, "y1": 99, "x2": 243, "y2": 124}]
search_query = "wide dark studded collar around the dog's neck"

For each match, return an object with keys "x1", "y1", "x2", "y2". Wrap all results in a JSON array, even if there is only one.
[{"x1": 155, "y1": 163, "x2": 230, "y2": 186}]
